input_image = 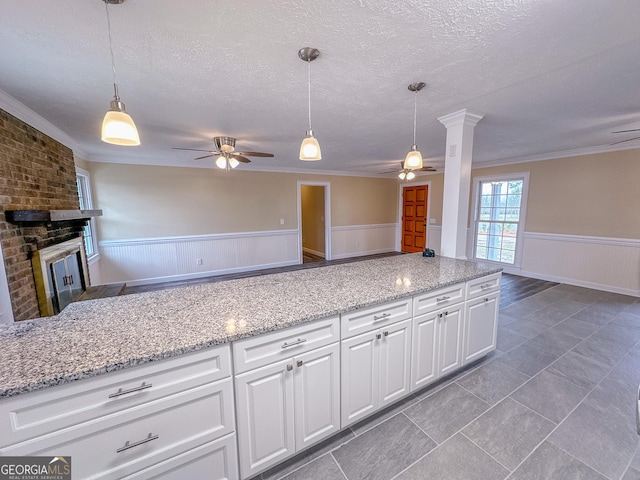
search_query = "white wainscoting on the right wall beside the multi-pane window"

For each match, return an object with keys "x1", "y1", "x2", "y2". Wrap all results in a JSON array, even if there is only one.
[{"x1": 514, "y1": 232, "x2": 640, "y2": 296}]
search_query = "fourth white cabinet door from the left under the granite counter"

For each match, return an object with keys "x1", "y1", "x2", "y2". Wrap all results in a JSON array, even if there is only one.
[{"x1": 378, "y1": 320, "x2": 411, "y2": 407}]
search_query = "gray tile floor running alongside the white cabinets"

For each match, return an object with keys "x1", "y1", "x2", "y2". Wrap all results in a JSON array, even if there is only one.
[{"x1": 256, "y1": 275, "x2": 640, "y2": 480}]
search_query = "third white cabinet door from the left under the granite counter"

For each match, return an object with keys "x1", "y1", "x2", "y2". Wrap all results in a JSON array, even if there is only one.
[{"x1": 340, "y1": 331, "x2": 382, "y2": 428}]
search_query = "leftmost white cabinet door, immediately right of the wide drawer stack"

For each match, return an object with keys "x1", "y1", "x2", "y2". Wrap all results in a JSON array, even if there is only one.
[{"x1": 236, "y1": 359, "x2": 295, "y2": 478}]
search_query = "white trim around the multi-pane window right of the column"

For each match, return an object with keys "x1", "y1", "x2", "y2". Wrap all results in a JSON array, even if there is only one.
[{"x1": 471, "y1": 172, "x2": 529, "y2": 268}]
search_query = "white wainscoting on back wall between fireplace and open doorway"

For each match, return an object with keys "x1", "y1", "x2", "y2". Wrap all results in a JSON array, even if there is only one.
[{"x1": 96, "y1": 230, "x2": 301, "y2": 285}]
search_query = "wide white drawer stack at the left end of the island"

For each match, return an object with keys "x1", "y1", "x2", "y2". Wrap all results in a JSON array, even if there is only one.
[{"x1": 0, "y1": 345, "x2": 237, "y2": 479}]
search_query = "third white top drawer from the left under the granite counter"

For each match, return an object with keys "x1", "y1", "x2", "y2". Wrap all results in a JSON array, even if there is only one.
[{"x1": 341, "y1": 298, "x2": 411, "y2": 340}]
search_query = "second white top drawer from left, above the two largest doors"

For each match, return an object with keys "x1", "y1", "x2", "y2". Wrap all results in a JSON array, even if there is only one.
[{"x1": 233, "y1": 317, "x2": 340, "y2": 374}]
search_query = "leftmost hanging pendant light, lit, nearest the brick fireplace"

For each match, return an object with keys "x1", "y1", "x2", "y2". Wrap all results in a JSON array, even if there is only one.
[{"x1": 102, "y1": 0, "x2": 140, "y2": 146}]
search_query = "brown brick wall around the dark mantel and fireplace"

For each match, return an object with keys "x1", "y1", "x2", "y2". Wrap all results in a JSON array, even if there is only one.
[{"x1": 0, "y1": 110, "x2": 82, "y2": 321}]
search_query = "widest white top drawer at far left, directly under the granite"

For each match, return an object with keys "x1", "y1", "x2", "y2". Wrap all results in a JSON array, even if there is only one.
[{"x1": 0, "y1": 345, "x2": 231, "y2": 447}]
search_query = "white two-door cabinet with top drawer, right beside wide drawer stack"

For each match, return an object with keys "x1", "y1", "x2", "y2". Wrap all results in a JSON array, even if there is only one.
[{"x1": 233, "y1": 317, "x2": 340, "y2": 478}]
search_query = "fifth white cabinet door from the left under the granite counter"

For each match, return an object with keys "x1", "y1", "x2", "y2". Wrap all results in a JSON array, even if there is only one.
[{"x1": 411, "y1": 312, "x2": 438, "y2": 390}]
